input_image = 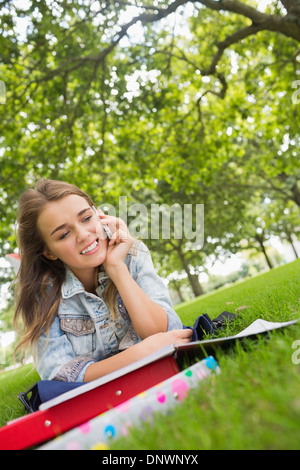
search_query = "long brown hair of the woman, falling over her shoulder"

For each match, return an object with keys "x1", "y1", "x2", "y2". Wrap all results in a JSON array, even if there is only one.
[{"x1": 14, "y1": 179, "x2": 115, "y2": 350}]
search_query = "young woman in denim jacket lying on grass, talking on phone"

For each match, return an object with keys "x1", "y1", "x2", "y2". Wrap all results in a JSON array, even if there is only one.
[{"x1": 15, "y1": 180, "x2": 192, "y2": 382}]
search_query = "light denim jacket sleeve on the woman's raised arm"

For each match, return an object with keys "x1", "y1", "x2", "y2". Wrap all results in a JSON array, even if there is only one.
[{"x1": 131, "y1": 242, "x2": 182, "y2": 331}]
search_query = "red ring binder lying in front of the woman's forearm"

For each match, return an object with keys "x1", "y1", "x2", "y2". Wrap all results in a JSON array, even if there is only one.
[{"x1": 0, "y1": 345, "x2": 180, "y2": 450}]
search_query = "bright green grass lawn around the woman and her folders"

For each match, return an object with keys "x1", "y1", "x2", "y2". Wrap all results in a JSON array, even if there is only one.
[{"x1": 0, "y1": 260, "x2": 300, "y2": 450}]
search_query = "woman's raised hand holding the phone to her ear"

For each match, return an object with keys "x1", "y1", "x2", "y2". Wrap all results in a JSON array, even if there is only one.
[{"x1": 98, "y1": 211, "x2": 134, "y2": 274}]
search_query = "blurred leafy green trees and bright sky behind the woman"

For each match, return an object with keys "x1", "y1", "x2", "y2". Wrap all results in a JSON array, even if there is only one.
[{"x1": 0, "y1": 0, "x2": 300, "y2": 367}]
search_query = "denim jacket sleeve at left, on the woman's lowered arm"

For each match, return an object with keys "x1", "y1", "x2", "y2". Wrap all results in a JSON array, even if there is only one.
[{"x1": 33, "y1": 317, "x2": 95, "y2": 382}]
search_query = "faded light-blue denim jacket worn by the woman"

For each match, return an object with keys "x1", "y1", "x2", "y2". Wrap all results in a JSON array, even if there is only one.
[{"x1": 34, "y1": 241, "x2": 182, "y2": 382}]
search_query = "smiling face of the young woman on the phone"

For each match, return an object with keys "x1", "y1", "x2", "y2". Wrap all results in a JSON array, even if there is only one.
[{"x1": 38, "y1": 194, "x2": 107, "y2": 289}]
